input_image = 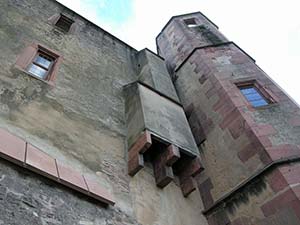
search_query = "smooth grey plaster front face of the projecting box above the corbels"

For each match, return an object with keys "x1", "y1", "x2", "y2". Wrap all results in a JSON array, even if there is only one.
[{"x1": 139, "y1": 85, "x2": 199, "y2": 156}]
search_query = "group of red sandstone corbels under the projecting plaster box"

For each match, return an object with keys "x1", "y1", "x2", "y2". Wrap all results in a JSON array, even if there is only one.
[{"x1": 128, "y1": 130, "x2": 204, "y2": 197}]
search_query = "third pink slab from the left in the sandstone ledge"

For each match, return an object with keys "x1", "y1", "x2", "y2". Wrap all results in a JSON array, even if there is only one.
[{"x1": 57, "y1": 162, "x2": 88, "y2": 191}]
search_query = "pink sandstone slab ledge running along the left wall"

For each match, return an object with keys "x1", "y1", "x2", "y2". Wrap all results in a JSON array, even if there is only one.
[{"x1": 0, "y1": 129, "x2": 115, "y2": 206}]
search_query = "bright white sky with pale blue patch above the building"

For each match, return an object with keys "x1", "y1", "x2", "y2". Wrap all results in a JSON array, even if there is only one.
[{"x1": 58, "y1": 0, "x2": 300, "y2": 103}]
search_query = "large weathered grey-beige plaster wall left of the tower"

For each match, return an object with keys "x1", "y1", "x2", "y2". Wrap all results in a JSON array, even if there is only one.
[{"x1": 0, "y1": 0, "x2": 207, "y2": 225}]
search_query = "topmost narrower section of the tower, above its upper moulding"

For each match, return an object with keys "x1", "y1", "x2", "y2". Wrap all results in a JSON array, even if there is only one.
[{"x1": 156, "y1": 13, "x2": 228, "y2": 75}]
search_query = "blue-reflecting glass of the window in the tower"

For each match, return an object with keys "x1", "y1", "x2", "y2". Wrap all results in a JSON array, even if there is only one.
[{"x1": 239, "y1": 86, "x2": 270, "y2": 107}]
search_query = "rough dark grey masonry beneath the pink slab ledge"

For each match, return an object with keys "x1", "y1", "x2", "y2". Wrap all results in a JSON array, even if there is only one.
[{"x1": 0, "y1": 160, "x2": 138, "y2": 225}]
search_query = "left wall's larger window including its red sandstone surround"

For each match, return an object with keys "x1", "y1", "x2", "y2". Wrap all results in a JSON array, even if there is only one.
[{"x1": 15, "y1": 43, "x2": 62, "y2": 85}]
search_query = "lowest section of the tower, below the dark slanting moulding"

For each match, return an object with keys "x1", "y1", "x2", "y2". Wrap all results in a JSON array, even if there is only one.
[{"x1": 208, "y1": 163, "x2": 300, "y2": 225}]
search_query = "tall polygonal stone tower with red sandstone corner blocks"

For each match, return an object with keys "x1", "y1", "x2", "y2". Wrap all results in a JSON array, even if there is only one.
[{"x1": 157, "y1": 13, "x2": 300, "y2": 225}]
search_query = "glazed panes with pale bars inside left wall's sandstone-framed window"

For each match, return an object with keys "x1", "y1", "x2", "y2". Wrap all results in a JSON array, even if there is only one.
[{"x1": 28, "y1": 49, "x2": 55, "y2": 80}]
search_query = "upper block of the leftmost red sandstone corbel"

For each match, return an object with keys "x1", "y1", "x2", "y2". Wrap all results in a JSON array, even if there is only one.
[{"x1": 128, "y1": 130, "x2": 152, "y2": 161}]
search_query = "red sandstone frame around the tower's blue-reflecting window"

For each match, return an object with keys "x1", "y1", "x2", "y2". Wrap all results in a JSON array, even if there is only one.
[{"x1": 235, "y1": 80, "x2": 276, "y2": 108}]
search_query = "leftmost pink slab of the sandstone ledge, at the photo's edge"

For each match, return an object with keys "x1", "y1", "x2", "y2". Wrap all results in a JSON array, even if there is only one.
[{"x1": 0, "y1": 129, "x2": 26, "y2": 165}]
